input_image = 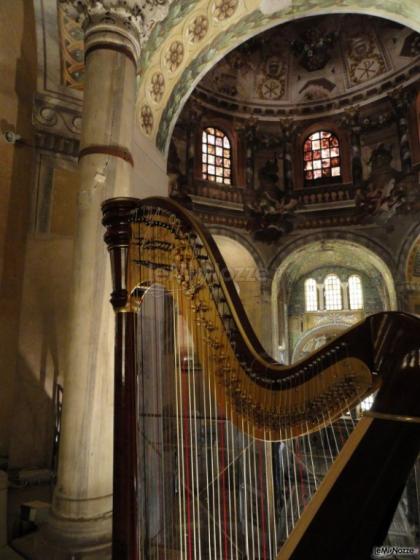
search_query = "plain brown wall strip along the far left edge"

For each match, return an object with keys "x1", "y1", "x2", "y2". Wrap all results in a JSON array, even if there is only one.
[{"x1": 0, "y1": 0, "x2": 37, "y2": 464}]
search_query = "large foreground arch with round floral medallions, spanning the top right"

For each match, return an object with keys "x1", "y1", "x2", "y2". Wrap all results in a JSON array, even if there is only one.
[{"x1": 137, "y1": 0, "x2": 420, "y2": 153}]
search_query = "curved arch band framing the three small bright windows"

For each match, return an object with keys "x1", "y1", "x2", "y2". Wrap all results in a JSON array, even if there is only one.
[{"x1": 270, "y1": 236, "x2": 398, "y2": 357}]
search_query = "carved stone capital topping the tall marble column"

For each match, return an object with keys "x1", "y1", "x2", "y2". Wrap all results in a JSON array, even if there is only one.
[{"x1": 59, "y1": 0, "x2": 173, "y2": 60}]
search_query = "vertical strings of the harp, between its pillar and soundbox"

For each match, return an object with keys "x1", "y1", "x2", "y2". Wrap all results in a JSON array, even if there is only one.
[{"x1": 135, "y1": 207, "x2": 364, "y2": 560}]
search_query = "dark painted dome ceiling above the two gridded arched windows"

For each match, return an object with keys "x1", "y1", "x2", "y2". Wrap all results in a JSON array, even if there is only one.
[{"x1": 198, "y1": 15, "x2": 420, "y2": 110}]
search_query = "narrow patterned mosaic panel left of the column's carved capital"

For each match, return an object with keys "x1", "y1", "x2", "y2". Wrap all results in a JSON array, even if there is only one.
[{"x1": 58, "y1": 6, "x2": 85, "y2": 90}]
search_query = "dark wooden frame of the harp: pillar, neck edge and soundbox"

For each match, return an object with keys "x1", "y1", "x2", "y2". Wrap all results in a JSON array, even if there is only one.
[{"x1": 103, "y1": 198, "x2": 420, "y2": 560}]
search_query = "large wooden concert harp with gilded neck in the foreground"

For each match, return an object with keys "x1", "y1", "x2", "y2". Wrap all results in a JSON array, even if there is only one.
[{"x1": 103, "y1": 198, "x2": 420, "y2": 560}]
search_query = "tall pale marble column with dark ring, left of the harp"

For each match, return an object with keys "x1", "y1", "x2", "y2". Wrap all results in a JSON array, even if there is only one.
[{"x1": 44, "y1": 1, "x2": 141, "y2": 558}]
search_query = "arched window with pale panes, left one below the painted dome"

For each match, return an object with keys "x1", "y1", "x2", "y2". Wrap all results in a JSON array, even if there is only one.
[{"x1": 201, "y1": 127, "x2": 232, "y2": 185}]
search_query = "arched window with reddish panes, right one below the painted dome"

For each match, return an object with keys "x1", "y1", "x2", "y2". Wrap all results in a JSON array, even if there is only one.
[{"x1": 303, "y1": 130, "x2": 341, "y2": 185}]
